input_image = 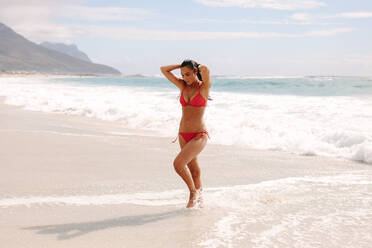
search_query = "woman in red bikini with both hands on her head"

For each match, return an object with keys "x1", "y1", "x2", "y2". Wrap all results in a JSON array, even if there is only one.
[{"x1": 160, "y1": 60, "x2": 211, "y2": 208}]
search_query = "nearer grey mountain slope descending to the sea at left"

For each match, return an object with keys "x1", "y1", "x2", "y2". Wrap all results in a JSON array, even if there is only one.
[{"x1": 0, "y1": 23, "x2": 121, "y2": 74}]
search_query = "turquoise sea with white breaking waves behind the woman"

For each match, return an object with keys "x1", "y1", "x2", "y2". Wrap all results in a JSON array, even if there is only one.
[{"x1": 0, "y1": 75, "x2": 372, "y2": 164}]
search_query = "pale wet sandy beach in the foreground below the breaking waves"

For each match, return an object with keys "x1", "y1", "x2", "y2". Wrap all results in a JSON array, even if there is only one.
[{"x1": 0, "y1": 101, "x2": 372, "y2": 248}]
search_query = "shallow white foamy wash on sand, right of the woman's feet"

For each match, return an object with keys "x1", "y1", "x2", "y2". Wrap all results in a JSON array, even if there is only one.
[{"x1": 199, "y1": 172, "x2": 372, "y2": 248}]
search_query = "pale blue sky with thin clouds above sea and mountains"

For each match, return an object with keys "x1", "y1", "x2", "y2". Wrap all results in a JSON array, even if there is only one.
[{"x1": 0, "y1": 0, "x2": 372, "y2": 76}]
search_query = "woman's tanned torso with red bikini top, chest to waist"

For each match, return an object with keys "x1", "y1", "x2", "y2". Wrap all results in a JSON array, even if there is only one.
[{"x1": 179, "y1": 86, "x2": 209, "y2": 132}]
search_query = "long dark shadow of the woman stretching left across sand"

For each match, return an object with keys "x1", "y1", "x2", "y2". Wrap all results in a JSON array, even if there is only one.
[{"x1": 23, "y1": 209, "x2": 187, "y2": 240}]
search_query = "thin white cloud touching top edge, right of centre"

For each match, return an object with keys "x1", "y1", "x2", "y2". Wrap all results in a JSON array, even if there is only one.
[{"x1": 194, "y1": 0, "x2": 326, "y2": 10}]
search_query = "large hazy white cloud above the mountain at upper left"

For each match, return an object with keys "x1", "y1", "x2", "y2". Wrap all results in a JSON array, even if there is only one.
[{"x1": 0, "y1": 0, "x2": 153, "y2": 42}]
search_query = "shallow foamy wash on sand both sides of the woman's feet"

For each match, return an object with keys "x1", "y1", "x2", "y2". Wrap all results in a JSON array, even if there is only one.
[{"x1": 0, "y1": 170, "x2": 372, "y2": 248}]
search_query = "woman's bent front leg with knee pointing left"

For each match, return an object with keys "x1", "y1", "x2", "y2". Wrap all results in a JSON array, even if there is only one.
[{"x1": 173, "y1": 136, "x2": 207, "y2": 208}]
